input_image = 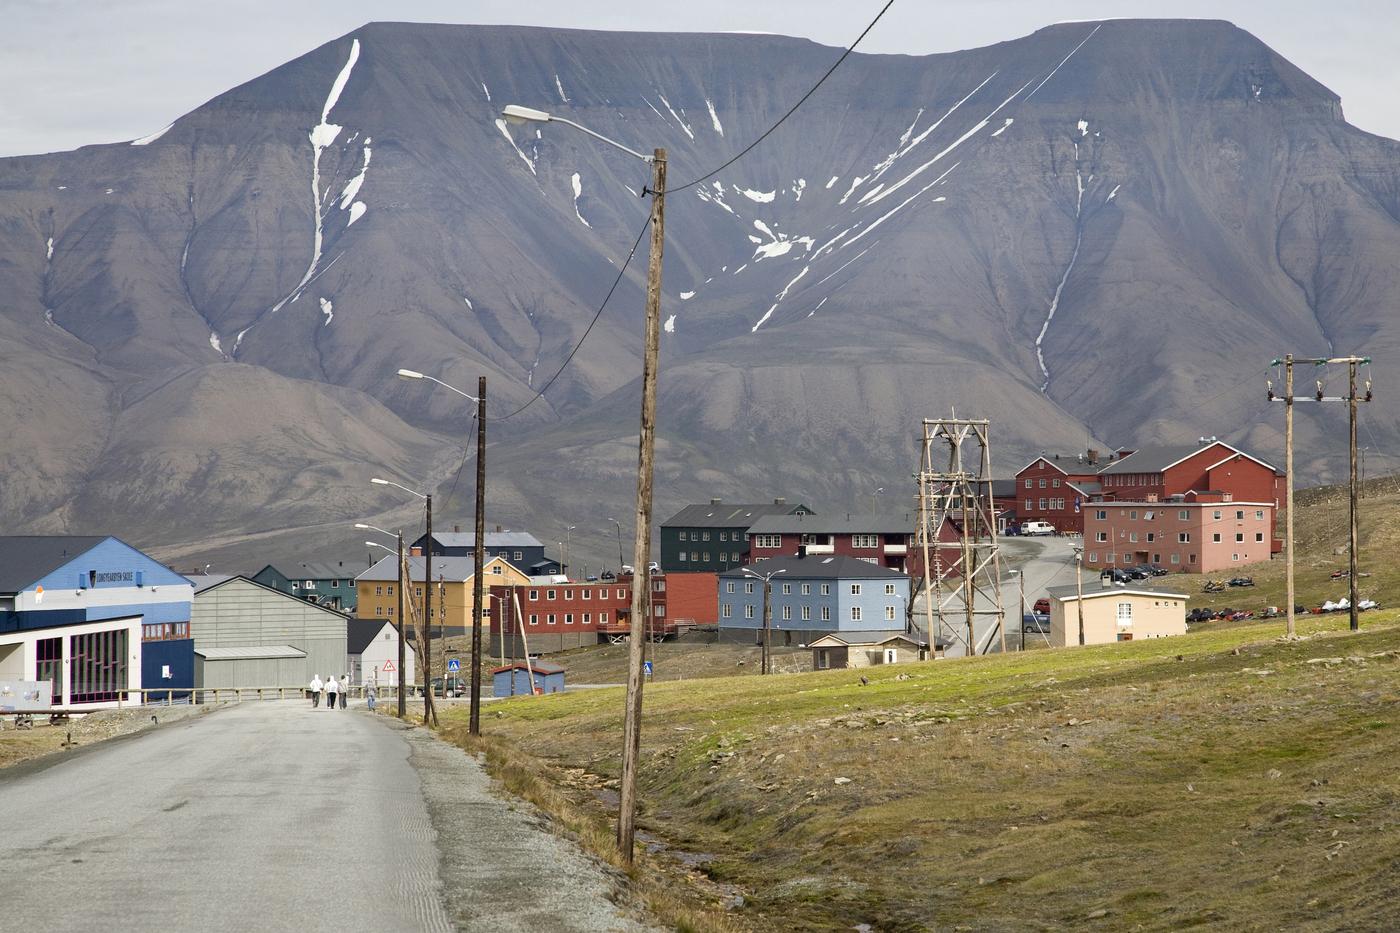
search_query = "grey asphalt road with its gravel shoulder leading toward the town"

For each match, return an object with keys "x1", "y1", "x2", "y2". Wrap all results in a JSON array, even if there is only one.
[{"x1": 0, "y1": 700, "x2": 634, "y2": 933}]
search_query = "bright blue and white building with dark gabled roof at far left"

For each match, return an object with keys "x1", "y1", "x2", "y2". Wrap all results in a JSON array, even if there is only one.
[{"x1": 0, "y1": 535, "x2": 195, "y2": 710}]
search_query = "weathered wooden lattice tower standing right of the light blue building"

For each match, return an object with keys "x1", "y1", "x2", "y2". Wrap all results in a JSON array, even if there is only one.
[{"x1": 916, "y1": 417, "x2": 1007, "y2": 656}]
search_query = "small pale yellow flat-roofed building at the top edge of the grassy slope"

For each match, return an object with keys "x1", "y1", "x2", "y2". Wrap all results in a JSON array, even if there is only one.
[{"x1": 1050, "y1": 581, "x2": 1187, "y2": 647}]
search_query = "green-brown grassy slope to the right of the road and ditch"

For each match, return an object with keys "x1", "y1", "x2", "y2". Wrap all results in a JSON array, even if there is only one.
[{"x1": 448, "y1": 612, "x2": 1400, "y2": 929}]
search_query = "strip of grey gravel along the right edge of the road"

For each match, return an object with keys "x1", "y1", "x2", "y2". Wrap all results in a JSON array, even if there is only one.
[{"x1": 389, "y1": 720, "x2": 657, "y2": 933}]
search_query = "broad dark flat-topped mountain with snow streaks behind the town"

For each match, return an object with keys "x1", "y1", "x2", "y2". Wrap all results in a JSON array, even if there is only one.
[{"x1": 0, "y1": 20, "x2": 1400, "y2": 566}]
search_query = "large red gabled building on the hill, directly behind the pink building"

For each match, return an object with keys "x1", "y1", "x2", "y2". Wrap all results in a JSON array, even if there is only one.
[{"x1": 1098, "y1": 440, "x2": 1287, "y2": 553}]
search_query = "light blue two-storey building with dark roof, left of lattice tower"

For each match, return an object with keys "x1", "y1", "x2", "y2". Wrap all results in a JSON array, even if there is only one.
[{"x1": 720, "y1": 555, "x2": 909, "y2": 644}]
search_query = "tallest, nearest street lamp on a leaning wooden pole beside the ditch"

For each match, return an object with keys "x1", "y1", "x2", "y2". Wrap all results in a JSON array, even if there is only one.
[{"x1": 501, "y1": 104, "x2": 666, "y2": 864}]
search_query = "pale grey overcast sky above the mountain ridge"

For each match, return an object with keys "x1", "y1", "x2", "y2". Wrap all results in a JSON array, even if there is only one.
[{"x1": 0, "y1": 0, "x2": 1400, "y2": 156}]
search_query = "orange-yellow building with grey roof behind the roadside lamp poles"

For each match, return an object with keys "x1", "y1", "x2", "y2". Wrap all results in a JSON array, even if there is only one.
[{"x1": 356, "y1": 556, "x2": 529, "y2": 632}]
